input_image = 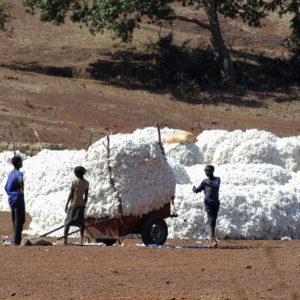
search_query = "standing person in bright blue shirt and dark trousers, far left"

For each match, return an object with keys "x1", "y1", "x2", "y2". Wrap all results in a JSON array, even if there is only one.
[{"x1": 4, "y1": 156, "x2": 25, "y2": 245}]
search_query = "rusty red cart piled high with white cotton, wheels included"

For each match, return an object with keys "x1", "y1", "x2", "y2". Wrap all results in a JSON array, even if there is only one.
[{"x1": 85, "y1": 128, "x2": 176, "y2": 245}]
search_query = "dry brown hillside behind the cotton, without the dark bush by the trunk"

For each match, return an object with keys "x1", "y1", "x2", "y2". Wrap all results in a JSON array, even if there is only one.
[{"x1": 0, "y1": 0, "x2": 300, "y2": 148}]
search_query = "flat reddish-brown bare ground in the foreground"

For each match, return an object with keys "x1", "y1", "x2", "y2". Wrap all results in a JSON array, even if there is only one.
[{"x1": 0, "y1": 212, "x2": 300, "y2": 299}]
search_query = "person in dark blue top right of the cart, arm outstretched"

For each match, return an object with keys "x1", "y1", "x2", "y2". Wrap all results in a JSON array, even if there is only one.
[{"x1": 193, "y1": 165, "x2": 221, "y2": 247}]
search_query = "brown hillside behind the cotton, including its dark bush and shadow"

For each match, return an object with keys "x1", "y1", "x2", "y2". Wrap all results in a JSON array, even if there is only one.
[{"x1": 0, "y1": 0, "x2": 300, "y2": 148}]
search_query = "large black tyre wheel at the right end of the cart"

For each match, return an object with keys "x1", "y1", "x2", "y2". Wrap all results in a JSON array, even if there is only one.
[{"x1": 141, "y1": 217, "x2": 168, "y2": 245}]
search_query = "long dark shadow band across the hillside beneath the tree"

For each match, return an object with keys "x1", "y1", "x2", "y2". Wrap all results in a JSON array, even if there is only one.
[{"x1": 0, "y1": 41, "x2": 299, "y2": 107}]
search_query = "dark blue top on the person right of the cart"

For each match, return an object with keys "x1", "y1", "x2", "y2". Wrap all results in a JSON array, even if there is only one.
[{"x1": 196, "y1": 177, "x2": 221, "y2": 206}]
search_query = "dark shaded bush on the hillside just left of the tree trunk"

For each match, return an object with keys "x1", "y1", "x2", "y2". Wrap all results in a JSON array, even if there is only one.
[{"x1": 147, "y1": 34, "x2": 222, "y2": 97}]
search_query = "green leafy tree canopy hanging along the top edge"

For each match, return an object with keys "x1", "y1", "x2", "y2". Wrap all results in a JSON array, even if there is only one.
[{"x1": 24, "y1": 0, "x2": 265, "y2": 41}]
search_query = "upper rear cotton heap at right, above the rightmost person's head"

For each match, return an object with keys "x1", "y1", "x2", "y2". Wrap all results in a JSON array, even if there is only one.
[{"x1": 196, "y1": 129, "x2": 300, "y2": 171}]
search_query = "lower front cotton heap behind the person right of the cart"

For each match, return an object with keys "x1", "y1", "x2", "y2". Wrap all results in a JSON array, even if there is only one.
[{"x1": 168, "y1": 164, "x2": 300, "y2": 239}]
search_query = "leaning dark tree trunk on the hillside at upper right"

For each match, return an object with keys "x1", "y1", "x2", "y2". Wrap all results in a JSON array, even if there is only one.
[{"x1": 206, "y1": 8, "x2": 236, "y2": 82}]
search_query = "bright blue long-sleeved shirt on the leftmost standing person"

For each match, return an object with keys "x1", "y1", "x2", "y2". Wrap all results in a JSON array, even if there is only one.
[{"x1": 4, "y1": 170, "x2": 24, "y2": 206}]
